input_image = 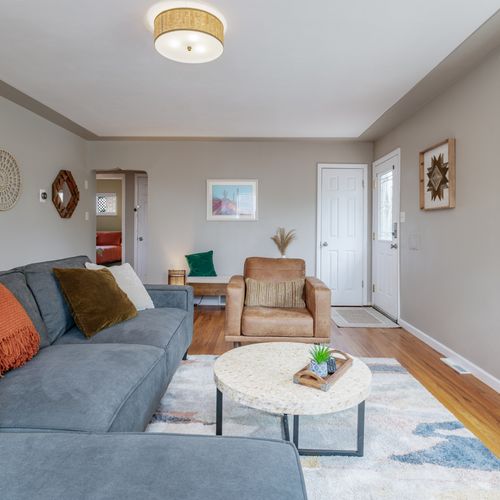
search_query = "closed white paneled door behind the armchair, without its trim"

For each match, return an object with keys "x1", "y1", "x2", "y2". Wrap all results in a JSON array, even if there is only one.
[{"x1": 319, "y1": 165, "x2": 366, "y2": 306}]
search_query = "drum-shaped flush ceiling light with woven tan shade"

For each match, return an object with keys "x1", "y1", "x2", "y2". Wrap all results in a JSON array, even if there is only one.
[{"x1": 148, "y1": 2, "x2": 225, "y2": 63}]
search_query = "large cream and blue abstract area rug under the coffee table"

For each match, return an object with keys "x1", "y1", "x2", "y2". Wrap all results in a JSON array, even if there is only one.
[{"x1": 147, "y1": 356, "x2": 500, "y2": 500}]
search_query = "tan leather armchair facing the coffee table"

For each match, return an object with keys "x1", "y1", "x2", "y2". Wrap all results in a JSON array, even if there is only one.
[{"x1": 225, "y1": 257, "x2": 331, "y2": 346}]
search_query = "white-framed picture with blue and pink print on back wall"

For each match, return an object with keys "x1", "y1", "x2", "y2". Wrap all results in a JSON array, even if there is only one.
[{"x1": 207, "y1": 179, "x2": 258, "y2": 221}]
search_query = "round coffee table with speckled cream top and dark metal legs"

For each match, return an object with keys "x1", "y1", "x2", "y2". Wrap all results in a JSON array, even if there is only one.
[{"x1": 214, "y1": 342, "x2": 372, "y2": 457}]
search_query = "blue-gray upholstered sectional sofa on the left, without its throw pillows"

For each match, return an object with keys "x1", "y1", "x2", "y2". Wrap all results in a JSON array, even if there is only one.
[{"x1": 0, "y1": 256, "x2": 306, "y2": 500}]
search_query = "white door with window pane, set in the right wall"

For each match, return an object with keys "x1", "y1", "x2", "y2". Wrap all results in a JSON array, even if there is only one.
[{"x1": 372, "y1": 151, "x2": 400, "y2": 320}]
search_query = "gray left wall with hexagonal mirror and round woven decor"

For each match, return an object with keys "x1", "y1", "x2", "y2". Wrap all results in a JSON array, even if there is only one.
[{"x1": 0, "y1": 98, "x2": 95, "y2": 269}]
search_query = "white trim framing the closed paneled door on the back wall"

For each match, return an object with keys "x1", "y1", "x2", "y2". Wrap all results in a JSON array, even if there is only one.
[{"x1": 316, "y1": 163, "x2": 369, "y2": 305}]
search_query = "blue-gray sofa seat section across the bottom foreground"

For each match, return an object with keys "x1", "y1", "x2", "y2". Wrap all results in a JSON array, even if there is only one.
[{"x1": 0, "y1": 433, "x2": 307, "y2": 500}]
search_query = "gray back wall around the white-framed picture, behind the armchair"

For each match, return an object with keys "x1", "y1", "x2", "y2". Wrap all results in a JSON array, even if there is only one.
[{"x1": 87, "y1": 141, "x2": 372, "y2": 283}]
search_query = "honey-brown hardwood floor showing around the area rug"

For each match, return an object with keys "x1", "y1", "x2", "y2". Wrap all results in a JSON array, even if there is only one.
[{"x1": 189, "y1": 306, "x2": 500, "y2": 456}]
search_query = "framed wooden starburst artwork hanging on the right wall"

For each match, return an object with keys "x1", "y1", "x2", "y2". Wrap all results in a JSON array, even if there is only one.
[{"x1": 419, "y1": 139, "x2": 456, "y2": 210}]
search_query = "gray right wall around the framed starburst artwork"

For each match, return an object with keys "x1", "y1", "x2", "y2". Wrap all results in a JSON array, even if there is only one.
[{"x1": 375, "y1": 45, "x2": 500, "y2": 377}]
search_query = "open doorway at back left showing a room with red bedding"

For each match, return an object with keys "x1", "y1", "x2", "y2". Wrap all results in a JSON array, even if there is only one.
[{"x1": 96, "y1": 169, "x2": 148, "y2": 282}]
